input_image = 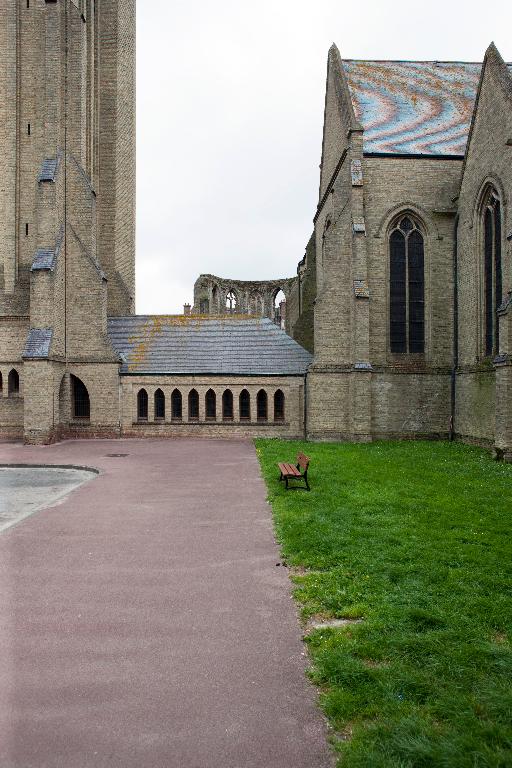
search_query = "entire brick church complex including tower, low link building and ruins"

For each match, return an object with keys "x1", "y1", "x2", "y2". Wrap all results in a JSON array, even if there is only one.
[{"x1": 0, "y1": 0, "x2": 512, "y2": 460}]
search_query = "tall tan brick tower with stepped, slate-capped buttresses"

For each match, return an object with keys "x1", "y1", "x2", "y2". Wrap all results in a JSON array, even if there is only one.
[{"x1": 0, "y1": 0, "x2": 135, "y2": 442}]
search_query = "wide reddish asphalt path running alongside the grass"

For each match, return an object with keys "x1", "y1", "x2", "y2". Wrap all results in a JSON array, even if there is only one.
[{"x1": 0, "y1": 439, "x2": 331, "y2": 768}]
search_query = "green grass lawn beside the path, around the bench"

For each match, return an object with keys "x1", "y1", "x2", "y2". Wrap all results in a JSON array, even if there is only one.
[{"x1": 256, "y1": 440, "x2": 512, "y2": 768}]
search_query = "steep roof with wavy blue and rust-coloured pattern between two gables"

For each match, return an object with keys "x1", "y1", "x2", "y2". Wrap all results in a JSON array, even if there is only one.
[{"x1": 342, "y1": 59, "x2": 512, "y2": 157}]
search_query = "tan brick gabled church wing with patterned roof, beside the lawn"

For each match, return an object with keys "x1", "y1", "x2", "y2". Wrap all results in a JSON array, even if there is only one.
[{"x1": 284, "y1": 45, "x2": 512, "y2": 461}]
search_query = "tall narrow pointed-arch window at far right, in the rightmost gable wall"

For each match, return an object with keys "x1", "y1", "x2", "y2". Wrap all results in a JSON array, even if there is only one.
[{"x1": 482, "y1": 187, "x2": 503, "y2": 355}]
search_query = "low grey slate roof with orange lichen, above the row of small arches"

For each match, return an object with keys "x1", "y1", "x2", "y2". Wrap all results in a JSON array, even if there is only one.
[{"x1": 108, "y1": 315, "x2": 312, "y2": 375}]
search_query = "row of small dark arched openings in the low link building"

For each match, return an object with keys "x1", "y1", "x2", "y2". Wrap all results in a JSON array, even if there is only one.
[{"x1": 136, "y1": 387, "x2": 285, "y2": 424}]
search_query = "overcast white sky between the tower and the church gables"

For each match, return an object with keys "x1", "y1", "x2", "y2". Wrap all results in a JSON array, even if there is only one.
[{"x1": 136, "y1": 0, "x2": 512, "y2": 314}]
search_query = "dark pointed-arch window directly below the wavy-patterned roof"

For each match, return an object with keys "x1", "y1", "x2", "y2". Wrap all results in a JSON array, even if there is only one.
[{"x1": 389, "y1": 215, "x2": 425, "y2": 353}]
